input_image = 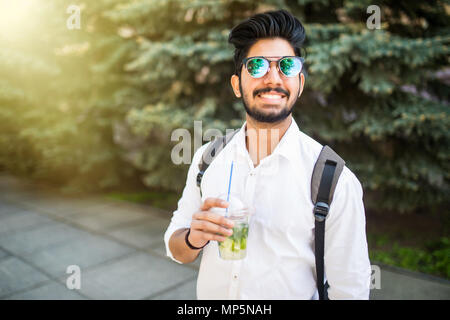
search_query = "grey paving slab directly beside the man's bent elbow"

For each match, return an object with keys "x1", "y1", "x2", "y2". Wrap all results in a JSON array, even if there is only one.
[{"x1": 108, "y1": 218, "x2": 169, "y2": 248}]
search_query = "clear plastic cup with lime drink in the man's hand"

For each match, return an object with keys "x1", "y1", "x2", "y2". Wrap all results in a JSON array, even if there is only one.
[{"x1": 214, "y1": 195, "x2": 252, "y2": 260}]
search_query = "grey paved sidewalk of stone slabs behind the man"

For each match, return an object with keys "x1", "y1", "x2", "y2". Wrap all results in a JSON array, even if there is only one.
[{"x1": 0, "y1": 176, "x2": 450, "y2": 299}]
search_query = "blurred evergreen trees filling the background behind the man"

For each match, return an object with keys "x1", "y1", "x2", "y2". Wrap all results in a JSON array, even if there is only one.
[{"x1": 0, "y1": 0, "x2": 450, "y2": 216}]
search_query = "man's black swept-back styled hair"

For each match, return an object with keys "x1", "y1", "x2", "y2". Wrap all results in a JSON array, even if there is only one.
[{"x1": 228, "y1": 10, "x2": 305, "y2": 77}]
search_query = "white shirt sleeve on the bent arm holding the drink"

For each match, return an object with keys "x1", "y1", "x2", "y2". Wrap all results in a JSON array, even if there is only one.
[{"x1": 164, "y1": 143, "x2": 208, "y2": 264}]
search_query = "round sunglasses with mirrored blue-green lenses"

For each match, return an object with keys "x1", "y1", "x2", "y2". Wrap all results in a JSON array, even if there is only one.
[{"x1": 242, "y1": 56, "x2": 305, "y2": 79}]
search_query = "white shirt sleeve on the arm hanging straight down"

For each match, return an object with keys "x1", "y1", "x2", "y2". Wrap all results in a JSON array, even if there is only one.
[{"x1": 324, "y1": 167, "x2": 371, "y2": 300}]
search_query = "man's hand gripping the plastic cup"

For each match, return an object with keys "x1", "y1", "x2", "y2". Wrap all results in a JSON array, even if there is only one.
[{"x1": 188, "y1": 198, "x2": 234, "y2": 247}]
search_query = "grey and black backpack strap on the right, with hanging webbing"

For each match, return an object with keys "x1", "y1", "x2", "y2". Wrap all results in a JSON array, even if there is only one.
[{"x1": 311, "y1": 146, "x2": 345, "y2": 300}]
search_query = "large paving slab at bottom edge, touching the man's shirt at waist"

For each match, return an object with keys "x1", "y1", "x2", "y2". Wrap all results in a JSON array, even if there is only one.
[{"x1": 77, "y1": 253, "x2": 195, "y2": 300}]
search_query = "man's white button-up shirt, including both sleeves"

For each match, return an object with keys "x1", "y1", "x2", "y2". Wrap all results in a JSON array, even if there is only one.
[{"x1": 164, "y1": 119, "x2": 371, "y2": 299}]
